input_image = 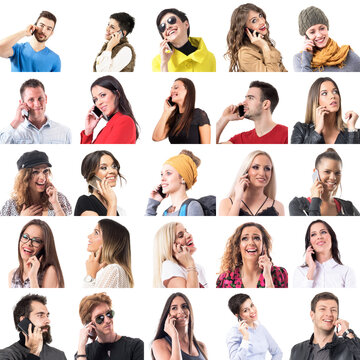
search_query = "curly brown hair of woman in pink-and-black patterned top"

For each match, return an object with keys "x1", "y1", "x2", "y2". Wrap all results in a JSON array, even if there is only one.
[{"x1": 220, "y1": 222, "x2": 272, "y2": 273}]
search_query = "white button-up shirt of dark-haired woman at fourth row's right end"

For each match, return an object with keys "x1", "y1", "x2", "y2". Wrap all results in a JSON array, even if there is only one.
[{"x1": 294, "y1": 258, "x2": 356, "y2": 288}]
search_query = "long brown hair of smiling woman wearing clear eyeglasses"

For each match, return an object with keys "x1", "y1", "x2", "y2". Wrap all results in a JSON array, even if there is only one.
[{"x1": 16, "y1": 219, "x2": 65, "y2": 288}]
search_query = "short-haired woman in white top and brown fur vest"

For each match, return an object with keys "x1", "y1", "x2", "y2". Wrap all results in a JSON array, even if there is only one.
[{"x1": 93, "y1": 12, "x2": 135, "y2": 72}]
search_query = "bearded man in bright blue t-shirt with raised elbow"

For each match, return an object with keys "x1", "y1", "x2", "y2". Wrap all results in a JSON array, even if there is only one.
[{"x1": 0, "y1": 11, "x2": 61, "y2": 72}]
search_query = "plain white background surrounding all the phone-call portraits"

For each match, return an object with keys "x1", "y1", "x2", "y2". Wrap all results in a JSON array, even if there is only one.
[{"x1": 0, "y1": 0, "x2": 360, "y2": 359}]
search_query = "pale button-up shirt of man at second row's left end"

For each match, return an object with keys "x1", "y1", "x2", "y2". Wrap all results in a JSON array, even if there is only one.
[{"x1": 0, "y1": 117, "x2": 71, "y2": 144}]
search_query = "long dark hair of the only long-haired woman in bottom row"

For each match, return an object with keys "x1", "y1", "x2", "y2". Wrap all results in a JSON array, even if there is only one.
[{"x1": 151, "y1": 292, "x2": 207, "y2": 360}]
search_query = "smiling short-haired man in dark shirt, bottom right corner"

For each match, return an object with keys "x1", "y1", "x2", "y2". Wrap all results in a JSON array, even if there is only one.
[{"x1": 290, "y1": 292, "x2": 360, "y2": 360}]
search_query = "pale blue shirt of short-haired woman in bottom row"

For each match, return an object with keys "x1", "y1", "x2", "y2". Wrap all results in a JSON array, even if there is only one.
[{"x1": 226, "y1": 324, "x2": 283, "y2": 360}]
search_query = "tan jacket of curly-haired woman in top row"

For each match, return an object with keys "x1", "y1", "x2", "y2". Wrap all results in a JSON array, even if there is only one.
[{"x1": 238, "y1": 47, "x2": 282, "y2": 72}]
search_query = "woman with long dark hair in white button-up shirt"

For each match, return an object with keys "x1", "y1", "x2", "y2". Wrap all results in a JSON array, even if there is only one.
[{"x1": 294, "y1": 220, "x2": 356, "y2": 288}]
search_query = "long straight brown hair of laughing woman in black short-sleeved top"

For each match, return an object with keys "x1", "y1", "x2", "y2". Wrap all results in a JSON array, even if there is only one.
[{"x1": 166, "y1": 78, "x2": 196, "y2": 136}]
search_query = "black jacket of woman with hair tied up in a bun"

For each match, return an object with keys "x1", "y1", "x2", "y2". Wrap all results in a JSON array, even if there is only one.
[{"x1": 289, "y1": 197, "x2": 360, "y2": 216}]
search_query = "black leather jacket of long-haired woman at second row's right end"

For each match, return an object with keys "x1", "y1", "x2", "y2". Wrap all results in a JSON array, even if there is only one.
[{"x1": 291, "y1": 122, "x2": 360, "y2": 144}]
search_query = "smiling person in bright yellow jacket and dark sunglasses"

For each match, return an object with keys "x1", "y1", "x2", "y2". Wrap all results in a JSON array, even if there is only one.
[{"x1": 152, "y1": 9, "x2": 216, "y2": 72}]
